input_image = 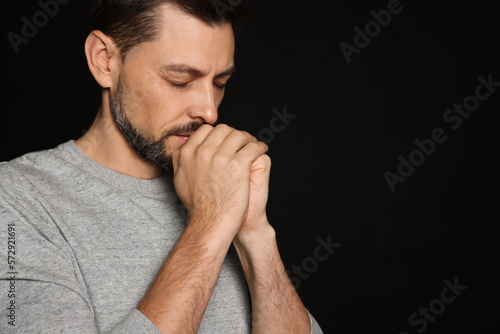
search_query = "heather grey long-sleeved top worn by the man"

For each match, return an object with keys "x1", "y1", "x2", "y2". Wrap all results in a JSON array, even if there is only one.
[{"x1": 0, "y1": 140, "x2": 322, "y2": 334}]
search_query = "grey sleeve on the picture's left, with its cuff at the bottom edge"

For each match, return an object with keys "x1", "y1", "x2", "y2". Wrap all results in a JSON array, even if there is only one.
[{"x1": 0, "y1": 166, "x2": 160, "y2": 334}]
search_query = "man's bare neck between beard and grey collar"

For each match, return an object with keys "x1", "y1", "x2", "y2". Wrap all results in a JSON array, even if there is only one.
[{"x1": 75, "y1": 90, "x2": 163, "y2": 180}]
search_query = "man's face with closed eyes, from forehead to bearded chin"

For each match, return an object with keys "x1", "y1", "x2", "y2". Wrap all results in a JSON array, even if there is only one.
[{"x1": 110, "y1": 4, "x2": 234, "y2": 168}]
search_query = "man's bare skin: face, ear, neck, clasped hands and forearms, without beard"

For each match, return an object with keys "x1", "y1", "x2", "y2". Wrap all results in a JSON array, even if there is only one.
[{"x1": 76, "y1": 5, "x2": 311, "y2": 333}]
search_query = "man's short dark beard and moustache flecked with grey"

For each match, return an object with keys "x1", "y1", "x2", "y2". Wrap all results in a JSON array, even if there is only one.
[{"x1": 110, "y1": 74, "x2": 203, "y2": 171}]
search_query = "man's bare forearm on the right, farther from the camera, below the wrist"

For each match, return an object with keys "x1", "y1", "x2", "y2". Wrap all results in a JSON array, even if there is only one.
[{"x1": 234, "y1": 225, "x2": 311, "y2": 334}]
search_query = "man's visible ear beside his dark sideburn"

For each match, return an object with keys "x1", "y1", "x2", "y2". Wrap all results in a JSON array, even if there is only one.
[{"x1": 85, "y1": 30, "x2": 121, "y2": 88}]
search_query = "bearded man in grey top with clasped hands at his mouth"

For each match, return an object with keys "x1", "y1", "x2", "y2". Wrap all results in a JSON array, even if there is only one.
[{"x1": 0, "y1": 0, "x2": 321, "y2": 333}]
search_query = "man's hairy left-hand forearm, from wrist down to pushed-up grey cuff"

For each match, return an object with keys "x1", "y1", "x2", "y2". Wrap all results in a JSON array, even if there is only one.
[{"x1": 137, "y1": 215, "x2": 231, "y2": 333}]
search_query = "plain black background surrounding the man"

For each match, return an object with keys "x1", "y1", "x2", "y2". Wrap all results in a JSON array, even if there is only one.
[{"x1": 0, "y1": 0, "x2": 500, "y2": 334}]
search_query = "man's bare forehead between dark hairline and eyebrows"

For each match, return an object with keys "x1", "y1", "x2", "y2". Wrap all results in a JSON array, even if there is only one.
[{"x1": 125, "y1": 3, "x2": 235, "y2": 72}]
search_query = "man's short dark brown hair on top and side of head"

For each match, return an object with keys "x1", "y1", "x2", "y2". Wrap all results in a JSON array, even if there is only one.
[{"x1": 90, "y1": 0, "x2": 251, "y2": 60}]
